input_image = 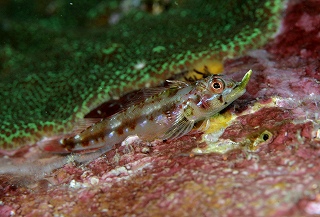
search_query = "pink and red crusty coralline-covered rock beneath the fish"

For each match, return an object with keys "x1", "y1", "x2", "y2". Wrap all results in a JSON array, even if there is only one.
[{"x1": 0, "y1": 1, "x2": 320, "y2": 216}]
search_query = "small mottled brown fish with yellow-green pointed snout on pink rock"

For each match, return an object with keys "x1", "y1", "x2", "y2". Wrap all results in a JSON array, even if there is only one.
[{"x1": 44, "y1": 70, "x2": 252, "y2": 151}]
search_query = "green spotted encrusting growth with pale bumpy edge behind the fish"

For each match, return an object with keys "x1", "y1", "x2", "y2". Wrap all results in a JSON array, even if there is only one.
[{"x1": 0, "y1": 0, "x2": 284, "y2": 150}]
